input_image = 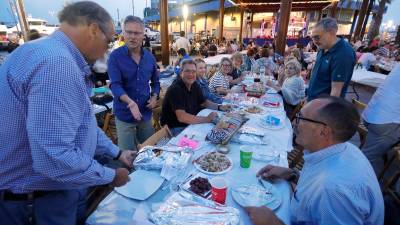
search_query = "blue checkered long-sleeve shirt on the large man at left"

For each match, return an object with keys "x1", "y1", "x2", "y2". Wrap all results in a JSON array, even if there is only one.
[{"x1": 0, "y1": 31, "x2": 118, "y2": 193}]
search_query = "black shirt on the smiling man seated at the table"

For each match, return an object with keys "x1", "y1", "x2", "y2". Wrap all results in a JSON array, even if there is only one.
[{"x1": 161, "y1": 78, "x2": 206, "y2": 128}]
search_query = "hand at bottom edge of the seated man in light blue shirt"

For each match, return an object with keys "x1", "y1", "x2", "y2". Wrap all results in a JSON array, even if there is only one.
[{"x1": 245, "y1": 206, "x2": 284, "y2": 225}]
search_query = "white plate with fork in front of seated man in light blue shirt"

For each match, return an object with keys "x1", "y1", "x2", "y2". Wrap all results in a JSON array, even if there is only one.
[{"x1": 231, "y1": 181, "x2": 282, "y2": 210}]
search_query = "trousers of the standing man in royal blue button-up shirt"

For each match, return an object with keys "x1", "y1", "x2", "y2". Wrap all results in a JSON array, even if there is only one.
[{"x1": 115, "y1": 118, "x2": 154, "y2": 150}]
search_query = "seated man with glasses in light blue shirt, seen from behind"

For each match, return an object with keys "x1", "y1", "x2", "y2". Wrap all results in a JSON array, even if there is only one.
[{"x1": 246, "y1": 97, "x2": 384, "y2": 225}]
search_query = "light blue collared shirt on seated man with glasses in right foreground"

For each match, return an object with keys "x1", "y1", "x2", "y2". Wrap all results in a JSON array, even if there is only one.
[{"x1": 290, "y1": 142, "x2": 384, "y2": 225}]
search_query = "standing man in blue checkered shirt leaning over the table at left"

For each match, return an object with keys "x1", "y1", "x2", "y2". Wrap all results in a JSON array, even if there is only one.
[{"x1": 0, "y1": 2, "x2": 135, "y2": 225}]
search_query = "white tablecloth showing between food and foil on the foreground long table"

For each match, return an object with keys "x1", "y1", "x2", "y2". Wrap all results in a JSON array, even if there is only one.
[{"x1": 86, "y1": 94, "x2": 293, "y2": 225}]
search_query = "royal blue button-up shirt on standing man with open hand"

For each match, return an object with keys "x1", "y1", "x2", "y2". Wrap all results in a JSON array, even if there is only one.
[{"x1": 108, "y1": 45, "x2": 160, "y2": 123}]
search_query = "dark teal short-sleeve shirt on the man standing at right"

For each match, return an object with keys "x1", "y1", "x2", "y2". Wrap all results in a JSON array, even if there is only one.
[{"x1": 307, "y1": 39, "x2": 356, "y2": 101}]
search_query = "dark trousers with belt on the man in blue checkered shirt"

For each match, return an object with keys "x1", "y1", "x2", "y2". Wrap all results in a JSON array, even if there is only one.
[{"x1": 0, "y1": 189, "x2": 86, "y2": 225}]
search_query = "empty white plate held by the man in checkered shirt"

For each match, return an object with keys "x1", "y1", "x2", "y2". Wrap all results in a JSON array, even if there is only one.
[{"x1": 115, "y1": 170, "x2": 164, "y2": 200}]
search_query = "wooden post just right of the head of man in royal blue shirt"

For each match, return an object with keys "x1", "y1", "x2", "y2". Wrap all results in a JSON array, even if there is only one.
[{"x1": 160, "y1": 0, "x2": 169, "y2": 66}]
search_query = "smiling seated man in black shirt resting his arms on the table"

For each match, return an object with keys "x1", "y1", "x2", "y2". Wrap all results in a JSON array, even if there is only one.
[{"x1": 161, "y1": 59, "x2": 229, "y2": 136}]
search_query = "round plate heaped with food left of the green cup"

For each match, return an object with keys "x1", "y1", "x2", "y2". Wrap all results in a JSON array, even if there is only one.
[{"x1": 193, "y1": 152, "x2": 233, "y2": 175}]
